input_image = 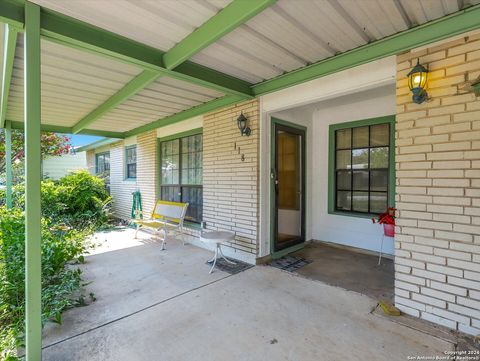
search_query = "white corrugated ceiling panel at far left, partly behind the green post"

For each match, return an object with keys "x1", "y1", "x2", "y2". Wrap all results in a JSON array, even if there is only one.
[{"x1": 7, "y1": 36, "x2": 141, "y2": 127}]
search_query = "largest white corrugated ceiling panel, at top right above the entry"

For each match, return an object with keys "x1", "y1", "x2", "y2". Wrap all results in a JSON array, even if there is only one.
[{"x1": 192, "y1": 0, "x2": 480, "y2": 83}]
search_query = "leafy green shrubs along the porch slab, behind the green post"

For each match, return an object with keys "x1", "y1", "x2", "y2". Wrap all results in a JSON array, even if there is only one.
[{"x1": 0, "y1": 171, "x2": 111, "y2": 360}]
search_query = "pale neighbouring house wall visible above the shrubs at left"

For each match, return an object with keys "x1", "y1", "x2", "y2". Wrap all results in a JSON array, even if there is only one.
[{"x1": 42, "y1": 151, "x2": 87, "y2": 179}]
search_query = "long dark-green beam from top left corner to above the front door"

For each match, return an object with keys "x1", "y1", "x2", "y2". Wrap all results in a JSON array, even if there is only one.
[{"x1": 0, "y1": 0, "x2": 253, "y2": 98}]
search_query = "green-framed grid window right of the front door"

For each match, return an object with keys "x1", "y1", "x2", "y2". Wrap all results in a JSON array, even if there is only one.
[{"x1": 329, "y1": 117, "x2": 395, "y2": 214}]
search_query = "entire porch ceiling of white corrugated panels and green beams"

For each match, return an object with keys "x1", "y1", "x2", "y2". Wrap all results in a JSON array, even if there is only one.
[{"x1": 0, "y1": 0, "x2": 480, "y2": 137}]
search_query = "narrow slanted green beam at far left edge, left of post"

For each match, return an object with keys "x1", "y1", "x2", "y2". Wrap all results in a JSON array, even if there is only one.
[{"x1": 0, "y1": 24, "x2": 18, "y2": 128}]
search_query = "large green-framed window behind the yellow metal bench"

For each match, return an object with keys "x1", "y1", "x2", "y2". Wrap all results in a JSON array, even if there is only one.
[{"x1": 160, "y1": 134, "x2": 203, "y2": 223}]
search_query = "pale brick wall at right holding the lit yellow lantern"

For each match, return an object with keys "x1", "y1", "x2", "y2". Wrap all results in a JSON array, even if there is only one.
[{"x1": 395, "y1": 35, "x2": 480, "y2": 334}]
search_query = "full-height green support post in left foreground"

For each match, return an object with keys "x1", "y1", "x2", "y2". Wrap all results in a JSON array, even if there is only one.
[{"x1": 24, "y1": 1, "x2": 42, "y2": 361}]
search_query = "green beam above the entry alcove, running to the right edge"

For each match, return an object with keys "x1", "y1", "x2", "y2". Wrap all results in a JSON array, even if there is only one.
[{"x1": 253, "y1": 5, "x2": 480, "y2": 96}]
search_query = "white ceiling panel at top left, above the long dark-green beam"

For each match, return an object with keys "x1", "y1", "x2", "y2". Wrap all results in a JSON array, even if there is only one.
[{"x1": 32, "y1": 0, "x2": 231, "y2": 51}]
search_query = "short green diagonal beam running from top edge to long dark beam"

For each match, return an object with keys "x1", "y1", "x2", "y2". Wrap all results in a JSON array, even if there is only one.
[{"x1": 163, "y1": 0, "x2": 276, "y2": 69}]
